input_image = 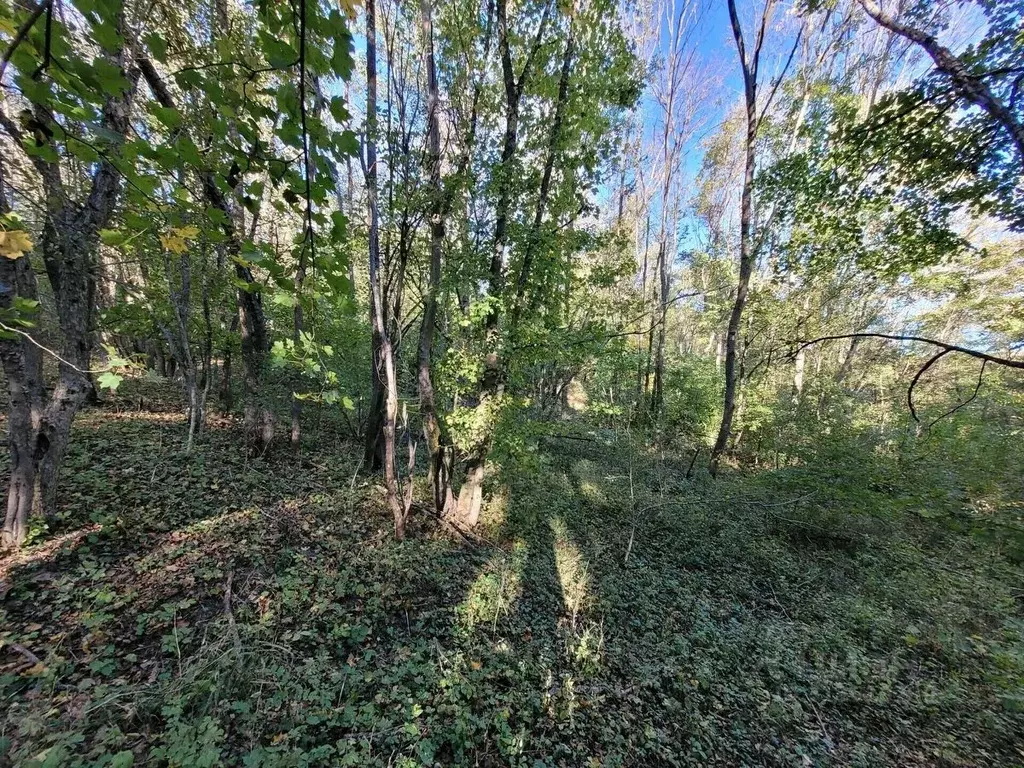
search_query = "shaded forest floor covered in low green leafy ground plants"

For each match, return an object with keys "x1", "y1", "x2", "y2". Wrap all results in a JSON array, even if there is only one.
[{"x1": 0, "y1": 384, "x2": 1024, "y2": 766}]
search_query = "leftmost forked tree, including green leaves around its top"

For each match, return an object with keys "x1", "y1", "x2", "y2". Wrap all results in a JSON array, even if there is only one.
[{"x1": 0, "y1": 2, "x2": 139, "y2": 547}]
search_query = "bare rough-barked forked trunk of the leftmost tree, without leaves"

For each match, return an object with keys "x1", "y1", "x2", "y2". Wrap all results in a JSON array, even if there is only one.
[{"x1": 0, "y1": 34, "x2": 138, "y2": 547}]
